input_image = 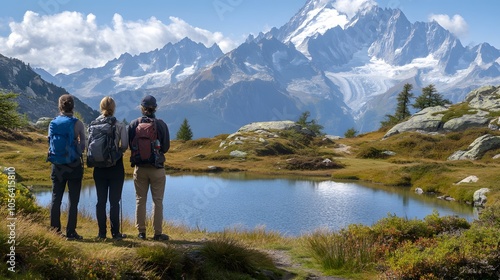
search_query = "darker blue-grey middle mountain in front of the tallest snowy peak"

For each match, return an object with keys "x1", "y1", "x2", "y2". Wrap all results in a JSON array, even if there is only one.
[{"x1": 115, "y1": 38, "x2": 354, "y2": 137}]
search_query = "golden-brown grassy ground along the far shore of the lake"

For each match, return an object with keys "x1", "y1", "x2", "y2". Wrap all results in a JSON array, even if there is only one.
[{"x1": 0, "y1": 126, "x2": 500, "y2": 205}]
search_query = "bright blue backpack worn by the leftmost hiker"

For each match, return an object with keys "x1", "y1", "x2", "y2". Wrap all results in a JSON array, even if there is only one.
[{"x1": 47, "y1": 116, "x2": 80, "y2": 164}]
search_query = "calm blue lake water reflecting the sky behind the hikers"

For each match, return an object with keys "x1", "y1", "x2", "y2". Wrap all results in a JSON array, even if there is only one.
[{"x1": 37, "y1": 175, "x2": 473, "y2": 235}]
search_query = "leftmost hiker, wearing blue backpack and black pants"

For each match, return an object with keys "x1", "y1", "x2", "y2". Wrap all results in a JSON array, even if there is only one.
[{"x1": 47, "y1": 94, "x2": 85, "y2": 240}]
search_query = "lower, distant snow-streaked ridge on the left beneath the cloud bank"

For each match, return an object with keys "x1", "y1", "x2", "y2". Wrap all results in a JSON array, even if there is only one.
[{"x1": 37, "y1": 38, "x2": 223, "y2": 108}]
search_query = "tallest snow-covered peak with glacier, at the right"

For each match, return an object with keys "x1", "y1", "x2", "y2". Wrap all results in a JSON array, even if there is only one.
[{"x1": 268, "y1": 0, "x2": 500, "y2": 131}]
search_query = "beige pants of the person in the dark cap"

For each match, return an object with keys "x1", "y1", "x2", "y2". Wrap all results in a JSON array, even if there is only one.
[{"x1": 134, "y1": 166, "x2": 166, "y2": 235}]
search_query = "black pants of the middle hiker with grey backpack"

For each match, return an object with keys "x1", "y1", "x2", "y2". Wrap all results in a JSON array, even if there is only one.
[{"x1": 93, "y1": 159, "x2": 125, "y2": 236}]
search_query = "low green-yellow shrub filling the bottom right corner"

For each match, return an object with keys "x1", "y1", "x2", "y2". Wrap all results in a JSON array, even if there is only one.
[{"x1": 386, "y1": 228, "x2": 500, "y2": 280}]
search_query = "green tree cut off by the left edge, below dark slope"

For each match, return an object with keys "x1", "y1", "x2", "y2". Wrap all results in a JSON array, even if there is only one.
[{"x1": 0, "y1": 92, "x2": 27, "y2": 129}]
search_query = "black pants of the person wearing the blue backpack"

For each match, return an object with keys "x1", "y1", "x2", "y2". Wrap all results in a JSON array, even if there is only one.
[{"x1": 50, "y1": 161, "x2": 83, "y2": 235}]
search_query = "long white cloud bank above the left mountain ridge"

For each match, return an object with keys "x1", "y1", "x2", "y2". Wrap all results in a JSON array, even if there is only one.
[{"x1": 0, "y1": 11, "x2": 236, "y2": 74}]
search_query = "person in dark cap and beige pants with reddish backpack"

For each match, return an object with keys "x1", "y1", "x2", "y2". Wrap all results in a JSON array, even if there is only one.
[{"x1": 128, "y1": 95, "x2": 170, "y2": 240}]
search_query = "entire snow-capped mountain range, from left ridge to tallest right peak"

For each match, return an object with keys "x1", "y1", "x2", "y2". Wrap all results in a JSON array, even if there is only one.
[{"x1": 34, "y1": 0, "x2": 500, "y2": 137}]
